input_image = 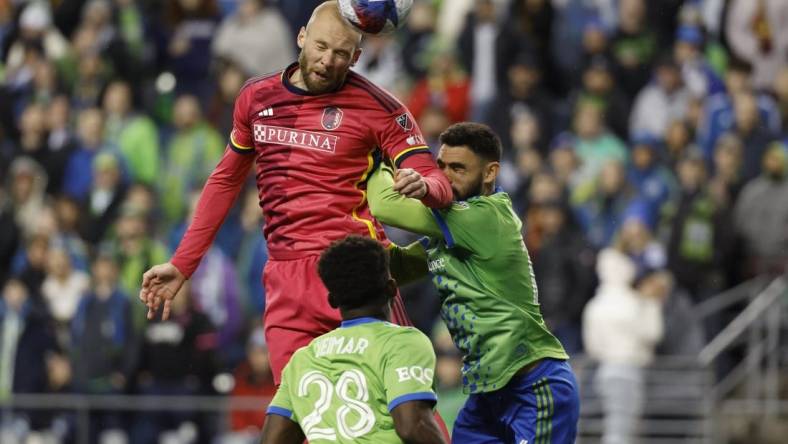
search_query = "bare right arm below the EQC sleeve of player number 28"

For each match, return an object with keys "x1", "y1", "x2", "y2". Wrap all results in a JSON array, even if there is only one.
[{"x1": 391, "y1": 401, "x2": 446, "y2": 444}]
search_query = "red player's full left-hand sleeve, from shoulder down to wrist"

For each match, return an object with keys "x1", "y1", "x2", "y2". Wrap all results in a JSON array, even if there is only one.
[{"x1": 172, "y1": 88, "x2": 255, "y2": 278}]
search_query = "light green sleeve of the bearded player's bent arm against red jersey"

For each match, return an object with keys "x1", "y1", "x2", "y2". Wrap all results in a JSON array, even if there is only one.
[{"x1": 367, "y1": 166, "x2": 442, "y2": 237}]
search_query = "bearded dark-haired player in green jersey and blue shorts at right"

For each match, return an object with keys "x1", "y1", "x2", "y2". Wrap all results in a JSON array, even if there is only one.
[{"x1": 367, "y1": 122, "x2": 579, "y2": 444}]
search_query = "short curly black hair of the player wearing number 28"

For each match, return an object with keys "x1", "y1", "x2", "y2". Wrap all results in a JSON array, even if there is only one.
[{"x1": 317, "y1": 235, "x2": 390, "y2": 310}]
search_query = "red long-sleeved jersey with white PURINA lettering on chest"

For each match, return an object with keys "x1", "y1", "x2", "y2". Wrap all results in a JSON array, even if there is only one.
[{"x1": 173, "y1": 64, "x2": 451, "y2": 276}]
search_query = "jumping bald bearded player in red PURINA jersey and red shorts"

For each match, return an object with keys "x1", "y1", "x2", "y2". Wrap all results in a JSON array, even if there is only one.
[{"x1": 140, "y1": 1, "x2": 452, "y2": 384}]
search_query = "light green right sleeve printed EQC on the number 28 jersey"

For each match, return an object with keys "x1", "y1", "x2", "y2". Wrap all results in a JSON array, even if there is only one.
[{"x1": 381, "y1": 328, "x2": 438, "y2": 411}]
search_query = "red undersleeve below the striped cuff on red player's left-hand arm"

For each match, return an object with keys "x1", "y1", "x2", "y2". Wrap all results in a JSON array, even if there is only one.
[{"x1": 172, "y1": 145, "x2": 255, "y2": 278}]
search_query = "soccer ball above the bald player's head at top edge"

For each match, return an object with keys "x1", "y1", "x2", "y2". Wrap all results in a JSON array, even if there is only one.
[{"x1": 338, "y1": 0, "x2": 413, "y2": 34}]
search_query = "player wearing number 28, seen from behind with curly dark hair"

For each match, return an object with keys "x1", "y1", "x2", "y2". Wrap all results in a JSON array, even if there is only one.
[{"x1": 262, "y1": 236, "x2": 445, "y2": 444}]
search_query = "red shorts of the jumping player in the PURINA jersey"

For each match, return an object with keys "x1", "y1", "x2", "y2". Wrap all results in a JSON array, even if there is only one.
[{"x1": 263, "y1": 255, "x2": 413, "y2": 385}]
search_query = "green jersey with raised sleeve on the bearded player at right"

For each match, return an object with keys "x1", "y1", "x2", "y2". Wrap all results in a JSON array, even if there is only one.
[{"x1": 368, "y1": 169, "x2": 569, "y2": 393}]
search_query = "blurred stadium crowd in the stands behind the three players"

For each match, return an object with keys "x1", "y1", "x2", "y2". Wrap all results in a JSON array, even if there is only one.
[{"x1": 0, "y1": 0, "x2": 788, "y2": 443}]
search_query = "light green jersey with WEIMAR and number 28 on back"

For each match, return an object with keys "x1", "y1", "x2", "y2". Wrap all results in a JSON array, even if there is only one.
[{"x1": 268, "y1": 318, "x2": 437, "y2": 444}]
